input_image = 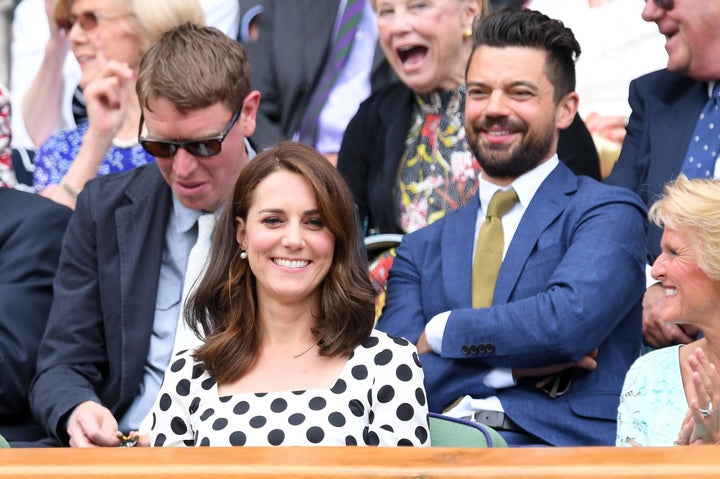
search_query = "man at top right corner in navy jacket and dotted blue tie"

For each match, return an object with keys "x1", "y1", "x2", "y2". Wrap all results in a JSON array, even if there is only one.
[{"x1": 605, "y1": 0, "x2": 720, "y2": 348}]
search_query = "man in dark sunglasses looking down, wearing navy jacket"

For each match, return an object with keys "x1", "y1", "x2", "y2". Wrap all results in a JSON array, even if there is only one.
[{"x1": 30, "y1": 24, "x2": 260, "y2": 447}]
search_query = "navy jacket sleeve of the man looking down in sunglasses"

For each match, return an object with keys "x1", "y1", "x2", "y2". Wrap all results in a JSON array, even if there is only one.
[{"x1": 30, "y1": 192, "x2": 108, "y2": 441}]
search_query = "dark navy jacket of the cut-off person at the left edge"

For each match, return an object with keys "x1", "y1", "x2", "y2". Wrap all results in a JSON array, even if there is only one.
[{"x1": 0, "y1": 188, "x2": 71, "y2": 442}]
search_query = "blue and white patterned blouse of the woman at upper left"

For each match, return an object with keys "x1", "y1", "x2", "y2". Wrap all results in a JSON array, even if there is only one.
[{"x1": 33, "y1": 122, "x2": 155, "y2": 192}]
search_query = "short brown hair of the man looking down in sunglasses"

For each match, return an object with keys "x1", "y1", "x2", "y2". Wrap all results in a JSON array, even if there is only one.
[{"x1": 135, "y1": 23, "x2": 251, "y2": 113}]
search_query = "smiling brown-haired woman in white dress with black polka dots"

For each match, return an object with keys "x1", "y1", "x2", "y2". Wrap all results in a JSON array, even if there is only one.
[{"x1": 151, "y1": 142, "x2": 429, "y2": 446}]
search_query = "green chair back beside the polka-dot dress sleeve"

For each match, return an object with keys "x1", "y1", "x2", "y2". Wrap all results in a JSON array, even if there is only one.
[{"x1": 428, "y1": 412, "x2": 507, "y2": 447}]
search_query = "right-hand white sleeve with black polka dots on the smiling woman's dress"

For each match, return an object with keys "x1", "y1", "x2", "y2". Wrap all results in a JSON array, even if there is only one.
[{"x1": 369, "y1": 336, "x2": 430, "y2": 446}]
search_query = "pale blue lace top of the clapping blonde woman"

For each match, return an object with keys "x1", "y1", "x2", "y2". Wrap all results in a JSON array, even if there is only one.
[{"x1": 615, "y1": 346, "x2": 688, "y2": 446}]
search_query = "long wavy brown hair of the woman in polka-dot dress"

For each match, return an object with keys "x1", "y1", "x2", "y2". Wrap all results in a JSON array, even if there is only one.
[{"x1": 185, "y1": 142, "x2": 375, "y2": 383}]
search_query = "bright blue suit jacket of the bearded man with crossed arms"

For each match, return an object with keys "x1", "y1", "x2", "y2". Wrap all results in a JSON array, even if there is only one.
[{"x1": 377, "y1": 163, "x2": 646, "y2": 446}]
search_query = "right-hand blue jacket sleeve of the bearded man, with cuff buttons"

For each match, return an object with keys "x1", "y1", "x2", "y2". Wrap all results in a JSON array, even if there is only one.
[{"x1": 442, "y1": 188, "x2": 646, "y2": 368}]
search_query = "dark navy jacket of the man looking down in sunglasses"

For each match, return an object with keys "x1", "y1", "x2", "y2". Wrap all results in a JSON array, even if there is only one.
[{"x1": 30, "y1": 163, "x2": 174, "y2": 443}]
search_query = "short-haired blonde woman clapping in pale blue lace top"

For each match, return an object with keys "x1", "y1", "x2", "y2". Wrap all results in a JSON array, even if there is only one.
[{"x1": 616, "y1": 175, "x2": 720, "y2": 446}]
